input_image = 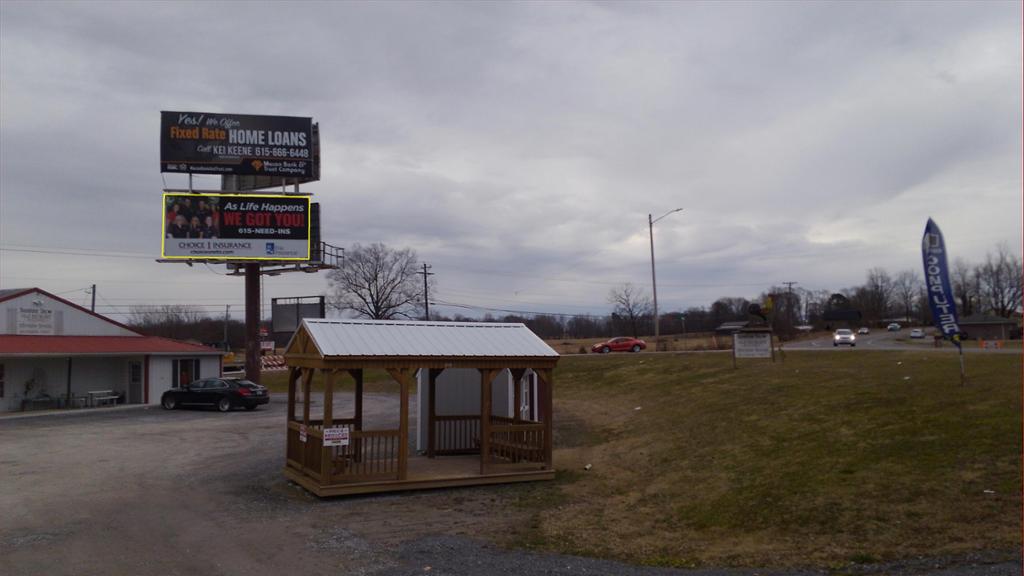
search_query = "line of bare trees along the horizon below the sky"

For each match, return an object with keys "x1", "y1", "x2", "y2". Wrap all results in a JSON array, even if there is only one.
[{"x1": 129, "y1": 243, "x2": 1024, "y2": 347}]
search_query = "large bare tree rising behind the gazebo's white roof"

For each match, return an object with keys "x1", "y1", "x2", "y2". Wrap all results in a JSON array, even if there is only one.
[{"x1": 328, "y1": 243, "x2": 423, "y2": 320}]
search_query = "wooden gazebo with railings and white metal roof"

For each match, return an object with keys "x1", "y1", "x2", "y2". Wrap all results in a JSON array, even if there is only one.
[{"x1": 285, "y1": 319, "x2": 558, "y2": 496}]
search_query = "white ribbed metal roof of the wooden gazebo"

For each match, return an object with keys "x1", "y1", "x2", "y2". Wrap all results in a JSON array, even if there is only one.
[{"x1": 302, "y1": 319, "x2": 558, "y2": 358}]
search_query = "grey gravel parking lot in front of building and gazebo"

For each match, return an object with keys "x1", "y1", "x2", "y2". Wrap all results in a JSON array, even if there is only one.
[{"x1": 0, "y1": 395, "x2": 1020, "y2": 576}]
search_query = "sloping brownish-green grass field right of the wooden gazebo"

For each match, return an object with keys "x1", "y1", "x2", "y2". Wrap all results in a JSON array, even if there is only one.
[{"x1": 508, "y1": 351, "x2": 1022, "y2": 568}]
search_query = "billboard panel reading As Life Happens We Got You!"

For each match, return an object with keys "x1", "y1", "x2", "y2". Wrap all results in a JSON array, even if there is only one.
[{"x1": 161, "y1": 193, "x2": 310, "y2": 260}]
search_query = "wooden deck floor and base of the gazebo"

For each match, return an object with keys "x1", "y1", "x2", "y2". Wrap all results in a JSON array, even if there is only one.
[{"x1": 285, "y1": 455, "x2": 555, "y2": 497}]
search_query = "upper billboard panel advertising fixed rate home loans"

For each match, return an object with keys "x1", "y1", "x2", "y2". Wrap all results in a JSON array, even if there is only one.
[{"x1": 160, "y1": 112, "x2": 314, "y2": 178}]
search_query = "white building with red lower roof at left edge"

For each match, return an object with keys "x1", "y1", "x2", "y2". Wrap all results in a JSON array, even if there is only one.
[{"x1": 0, "y1": 288, "x2": 221, "y2": 412}]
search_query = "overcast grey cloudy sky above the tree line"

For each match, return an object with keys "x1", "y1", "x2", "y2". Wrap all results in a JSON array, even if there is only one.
[{"x1": 0, "y1": 0, "x2": 1022, "y2": 319}]
